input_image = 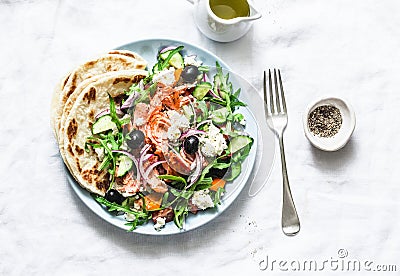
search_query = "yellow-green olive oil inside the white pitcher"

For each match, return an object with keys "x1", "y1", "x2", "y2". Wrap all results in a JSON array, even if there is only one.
[{"x1": 210, "y1": 0, "x2": 250, "y2": 19}]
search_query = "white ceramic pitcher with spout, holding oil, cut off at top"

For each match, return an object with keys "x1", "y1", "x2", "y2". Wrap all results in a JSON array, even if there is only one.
[{"x1": 188, "y1": 0, "x2": 261, "y2": 42}]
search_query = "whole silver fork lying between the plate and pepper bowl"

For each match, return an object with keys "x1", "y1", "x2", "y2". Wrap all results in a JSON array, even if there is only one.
[{"x1": 264, "y1": 69, "x2": 300, "y2": 236}]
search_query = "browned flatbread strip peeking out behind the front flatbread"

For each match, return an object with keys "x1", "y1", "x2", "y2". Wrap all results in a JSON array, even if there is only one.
[{"x1": 51, "y1": 50, "x2": 147, "y2": 139}]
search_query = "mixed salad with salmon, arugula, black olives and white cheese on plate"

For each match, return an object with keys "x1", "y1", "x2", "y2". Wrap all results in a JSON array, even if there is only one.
[{"x1": 86, "y1": 46, "x2": 253, "y2": 231}]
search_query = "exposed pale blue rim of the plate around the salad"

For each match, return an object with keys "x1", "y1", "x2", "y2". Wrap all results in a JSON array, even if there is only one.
[{"x1": 65, "y1": 38, "x2": 260, "y2": 236}]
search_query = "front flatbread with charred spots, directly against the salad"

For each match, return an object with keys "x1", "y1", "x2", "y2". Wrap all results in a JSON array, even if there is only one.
[{"x1": 60, "y1": 70, "x2": 147, "y2": 196}]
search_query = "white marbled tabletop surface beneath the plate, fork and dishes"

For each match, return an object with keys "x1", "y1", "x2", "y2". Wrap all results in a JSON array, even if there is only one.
[{"x1": 0, "y1": 0, "x2": 400, "y2": 275}]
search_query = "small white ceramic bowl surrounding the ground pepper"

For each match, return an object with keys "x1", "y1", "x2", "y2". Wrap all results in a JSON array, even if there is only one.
[{"x1": 303, "y1": 97, "x2": 356, "y2": 151}]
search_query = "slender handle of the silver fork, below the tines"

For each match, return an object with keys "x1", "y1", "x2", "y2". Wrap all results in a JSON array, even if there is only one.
[{"x1": 279, "y1": 135, "x2": 300, "y2": 236}]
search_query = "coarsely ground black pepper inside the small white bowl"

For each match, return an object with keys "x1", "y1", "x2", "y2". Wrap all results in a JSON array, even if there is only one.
[{"x1": 308, "y1": 105, "x2": 342, "y2": 137}]
